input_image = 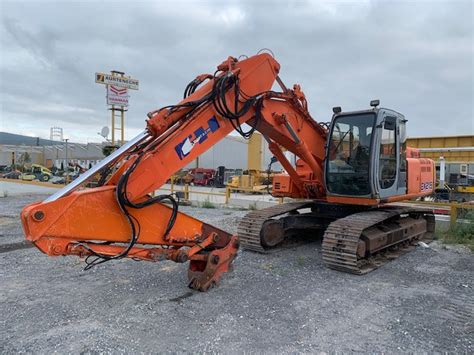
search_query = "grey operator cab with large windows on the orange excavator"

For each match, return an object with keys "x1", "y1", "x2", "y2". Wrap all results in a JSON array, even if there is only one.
[{"x1": 325, "y1": 100, "x2": 407, "y2": 199}]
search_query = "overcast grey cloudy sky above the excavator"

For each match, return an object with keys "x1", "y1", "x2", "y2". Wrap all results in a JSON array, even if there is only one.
[{"x1": 0, "y1": 0, "x2": 474, "y2": 142}]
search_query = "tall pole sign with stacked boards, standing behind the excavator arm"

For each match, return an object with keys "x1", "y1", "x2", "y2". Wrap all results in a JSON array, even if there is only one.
[{"x1": 95, "y1": 70, "x2": 138, "y2": 146}]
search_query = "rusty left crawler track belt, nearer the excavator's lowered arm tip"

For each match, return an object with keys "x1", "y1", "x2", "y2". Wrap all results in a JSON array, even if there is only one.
[{"x1": 237, "y1": 201, "x2": 313, "y2": 253}]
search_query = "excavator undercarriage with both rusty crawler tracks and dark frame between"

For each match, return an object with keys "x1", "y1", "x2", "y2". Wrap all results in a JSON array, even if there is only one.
[{"x1": 238, "y1": 201, "x2": 435, "y2": 274}]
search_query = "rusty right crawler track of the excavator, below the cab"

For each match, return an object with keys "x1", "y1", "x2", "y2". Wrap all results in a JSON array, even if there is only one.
[{"x1": 322, "y1": 208, "x2": 435, "y2": 274}]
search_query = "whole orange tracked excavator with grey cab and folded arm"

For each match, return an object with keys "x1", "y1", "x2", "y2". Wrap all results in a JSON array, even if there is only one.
[{"x1": 21, "y1": 53, "x2": 435, "y2": 291}]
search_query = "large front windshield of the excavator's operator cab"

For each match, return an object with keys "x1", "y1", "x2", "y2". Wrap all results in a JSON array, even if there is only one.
[{"x1": 326, "y1": 113, "x2": 375, "y2": 196}]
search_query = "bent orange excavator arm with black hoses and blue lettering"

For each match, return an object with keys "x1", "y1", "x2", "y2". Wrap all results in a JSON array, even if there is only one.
[{"x1": 21, "y1": 53, "x2": 326, "y2": 291}]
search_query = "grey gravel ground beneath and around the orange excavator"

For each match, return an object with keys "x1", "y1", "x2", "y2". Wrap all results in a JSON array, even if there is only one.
[{"x1": 0, "y1": 196, "x2": 474, "y2": 354}]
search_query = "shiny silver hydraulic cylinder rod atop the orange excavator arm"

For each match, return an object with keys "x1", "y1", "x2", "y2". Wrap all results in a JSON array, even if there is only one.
[{"x1": 44, "y1": 130, "x2": 150, "y2": 202}]
